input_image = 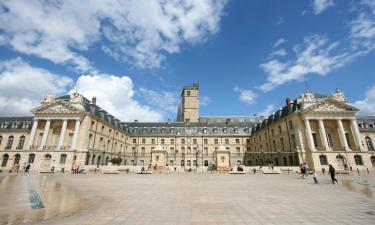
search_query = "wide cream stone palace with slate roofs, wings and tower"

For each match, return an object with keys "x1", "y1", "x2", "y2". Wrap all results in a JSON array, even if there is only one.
[{"x1": 0, "y1": 84, "x2": 375, "y2": 171}]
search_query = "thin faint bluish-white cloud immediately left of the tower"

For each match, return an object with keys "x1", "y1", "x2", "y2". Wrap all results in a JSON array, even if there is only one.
[{"x1": 139, "y1": 88, "x2": 179, "y2": 113}]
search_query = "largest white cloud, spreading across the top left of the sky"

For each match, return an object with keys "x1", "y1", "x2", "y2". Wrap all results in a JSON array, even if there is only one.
[{"x1": 0, "y1": 0, "x2": 226, "y2": 72}]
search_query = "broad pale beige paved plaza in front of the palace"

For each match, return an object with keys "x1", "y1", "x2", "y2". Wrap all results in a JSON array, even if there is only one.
[{"x1": 0, "y1": 173, "x2": 375, "y2": 225}]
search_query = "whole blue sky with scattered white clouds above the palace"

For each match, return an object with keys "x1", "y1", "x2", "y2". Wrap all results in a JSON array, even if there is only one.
[{"x1": 0, "y1": 0, "x2": 375, "y2": 121}]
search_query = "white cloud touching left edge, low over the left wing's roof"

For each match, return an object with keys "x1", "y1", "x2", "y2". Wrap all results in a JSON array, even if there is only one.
[{"x1": 0, "y1": 58, "x2": 72, "y2": 116}]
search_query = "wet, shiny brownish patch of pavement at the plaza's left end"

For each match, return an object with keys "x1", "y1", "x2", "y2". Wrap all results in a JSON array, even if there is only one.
[{"x1": 0, "y1": 174, "x2": 87, "y2": 225}]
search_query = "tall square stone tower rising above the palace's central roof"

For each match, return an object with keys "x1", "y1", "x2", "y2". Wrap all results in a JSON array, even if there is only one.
[{"x1": 177, "y1": 83, "x2": 199, "y2": 122}]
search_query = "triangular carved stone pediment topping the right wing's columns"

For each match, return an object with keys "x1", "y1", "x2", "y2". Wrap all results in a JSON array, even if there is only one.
[{"x1": 305, "y1": 98, "x2": 359, "y2": 112}]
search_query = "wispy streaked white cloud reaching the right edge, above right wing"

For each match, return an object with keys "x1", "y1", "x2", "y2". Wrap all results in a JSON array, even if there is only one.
[{"x1": 260, "y1": 0, "x2": 375, "y2": 91}]
